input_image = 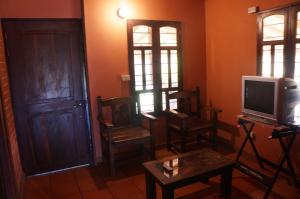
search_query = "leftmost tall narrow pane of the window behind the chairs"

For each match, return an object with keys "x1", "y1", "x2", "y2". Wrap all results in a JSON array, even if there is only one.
[{"x1": 134, "y1": 50, "x2": 143, "y2": 91}]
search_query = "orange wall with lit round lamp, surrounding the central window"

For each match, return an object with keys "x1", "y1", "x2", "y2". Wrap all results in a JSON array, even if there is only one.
[{"x1": 84, "y1": 0, "x2": 206, "y2": 160}]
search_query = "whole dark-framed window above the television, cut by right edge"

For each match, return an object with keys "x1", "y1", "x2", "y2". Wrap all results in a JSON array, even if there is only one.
[{"x1": 257, "y1": 3, "x2": 300, "y2": 121}]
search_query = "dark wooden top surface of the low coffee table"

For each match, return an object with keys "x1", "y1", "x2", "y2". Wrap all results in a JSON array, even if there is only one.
[{"x1": 143, "y1": 149, "x2": 235, "y2": 185}]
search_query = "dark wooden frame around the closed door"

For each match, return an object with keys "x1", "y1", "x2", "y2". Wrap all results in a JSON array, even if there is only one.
[{"x1": 0, "y1": 18, "x2": 95, "y2": 169}]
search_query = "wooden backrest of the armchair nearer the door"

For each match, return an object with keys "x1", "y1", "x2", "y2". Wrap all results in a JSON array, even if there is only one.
[{"x1": 97, "y1": 96, "x2": 139, "y2": 127}]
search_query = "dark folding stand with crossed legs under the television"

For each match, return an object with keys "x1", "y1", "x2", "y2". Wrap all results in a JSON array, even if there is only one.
[{"x1": 236, "y1": 115, "x2": 300, "y2": 199}]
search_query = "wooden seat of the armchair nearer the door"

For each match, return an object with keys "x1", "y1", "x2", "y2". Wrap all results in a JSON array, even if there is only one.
[{"x1": 105, "y1": 126, "x2": 151, "y2": 143}]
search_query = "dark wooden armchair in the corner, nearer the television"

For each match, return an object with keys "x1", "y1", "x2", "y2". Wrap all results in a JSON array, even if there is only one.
[{"x1": 166, "y1": 87, "x2": 222, "y2": 152}]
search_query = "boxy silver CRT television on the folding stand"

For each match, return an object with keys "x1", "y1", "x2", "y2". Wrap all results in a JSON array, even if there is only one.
[{"x1": 242, "y1": 76, "x2": 300, "y2": 124}]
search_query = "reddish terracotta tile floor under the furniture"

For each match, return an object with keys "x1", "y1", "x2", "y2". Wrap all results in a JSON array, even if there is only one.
[{"x1": 24, "y1": 150, "x2": 300, "y2": 199}]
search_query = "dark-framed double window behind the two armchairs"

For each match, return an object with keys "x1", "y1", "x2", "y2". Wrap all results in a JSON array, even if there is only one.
[{"x1": 127, "y1": 20, "x2": 182, "y2": 113}]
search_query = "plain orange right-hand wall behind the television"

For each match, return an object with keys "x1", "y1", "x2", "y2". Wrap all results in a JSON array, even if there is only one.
[{"x1": 205, "y1": 0, "x2": 300, "y2": 168}]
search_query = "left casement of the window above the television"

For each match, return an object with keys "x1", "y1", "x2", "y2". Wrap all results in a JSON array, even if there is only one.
[{"x1": 258, "y1": 10, "x2": 288, "y2": 77}]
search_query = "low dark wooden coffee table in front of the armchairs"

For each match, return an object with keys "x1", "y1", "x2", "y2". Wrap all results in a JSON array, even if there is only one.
[{"x1": 143, "y1": 149, "x2": 235, "y2": 199}]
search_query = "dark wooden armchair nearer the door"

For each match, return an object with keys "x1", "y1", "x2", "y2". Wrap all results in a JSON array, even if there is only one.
[{"x1": 97, "y1": 96, "x2": 157, "y2": 176}]
